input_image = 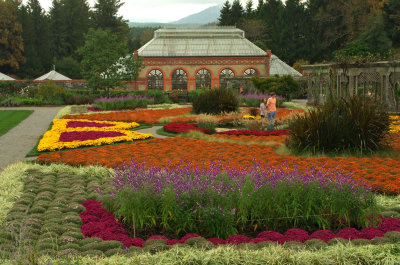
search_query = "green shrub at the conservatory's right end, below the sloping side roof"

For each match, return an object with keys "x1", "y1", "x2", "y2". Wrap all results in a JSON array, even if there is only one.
[{"x1": 251, "y1": 75, "x2": 300, "y2": 100}]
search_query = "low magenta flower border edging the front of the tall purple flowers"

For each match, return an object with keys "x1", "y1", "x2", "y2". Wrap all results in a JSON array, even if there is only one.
[{"x1": 79, "y1": 200, "x2": 400, "y2": 248}]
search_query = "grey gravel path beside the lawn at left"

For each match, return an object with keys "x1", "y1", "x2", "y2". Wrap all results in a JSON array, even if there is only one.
[{"x1": 0, "y1": 106, "x2": 63, "y2": 172}]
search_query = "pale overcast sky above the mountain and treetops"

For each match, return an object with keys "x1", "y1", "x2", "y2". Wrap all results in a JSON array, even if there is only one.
[{"x1": 23, "y1": 0, "x2": 258, "y2": 22}]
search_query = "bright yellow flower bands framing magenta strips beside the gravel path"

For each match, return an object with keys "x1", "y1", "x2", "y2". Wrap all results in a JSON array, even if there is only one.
[{"x1": 37, "y1": 119, "x2": 153, "y2": 152}]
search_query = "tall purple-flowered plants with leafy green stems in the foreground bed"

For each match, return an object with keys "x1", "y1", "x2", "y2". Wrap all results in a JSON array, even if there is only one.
[{"x1": 103, "y1": 160, "x2": 378, "y2": 239}]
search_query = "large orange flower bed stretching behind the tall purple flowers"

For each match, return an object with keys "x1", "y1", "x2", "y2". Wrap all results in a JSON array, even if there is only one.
[{"x1": 38, "y1": 137, "x2": 400, "y2": 194}]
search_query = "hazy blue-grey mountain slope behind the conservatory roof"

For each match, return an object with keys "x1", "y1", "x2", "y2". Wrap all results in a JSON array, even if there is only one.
[{"x1": 129, "y1": 5, "x2": 221, "y2": 28}]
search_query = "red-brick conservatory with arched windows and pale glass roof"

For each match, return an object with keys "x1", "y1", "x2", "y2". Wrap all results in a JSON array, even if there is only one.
[{"x1": 133, "y1": 27, "x2": 301, "y2": 90}]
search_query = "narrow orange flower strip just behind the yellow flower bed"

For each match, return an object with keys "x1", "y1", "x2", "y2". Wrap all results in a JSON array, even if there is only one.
[{"x1": 63, "y1": 107, "x2": 192, "y2": 124}]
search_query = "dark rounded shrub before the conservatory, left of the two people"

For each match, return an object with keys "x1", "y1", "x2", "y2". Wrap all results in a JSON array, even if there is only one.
[{"x1": 193, "y1": 88, "x2": 238, "y2": 114}]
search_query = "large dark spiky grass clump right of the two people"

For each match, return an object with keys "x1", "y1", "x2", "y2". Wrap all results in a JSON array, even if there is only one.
[{"x1": 288, "y1": 97, "x2": 389, "y2": 153}]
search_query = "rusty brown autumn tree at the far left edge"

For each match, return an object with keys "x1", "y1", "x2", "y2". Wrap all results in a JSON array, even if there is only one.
[{"x1": 0, "y1": 0, "x2": 25, "y2": 72}]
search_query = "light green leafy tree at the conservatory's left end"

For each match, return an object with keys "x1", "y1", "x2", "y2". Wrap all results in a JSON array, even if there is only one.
[{"x1": 78, "y1": 29, "x2": 142, "y2": 94}]
